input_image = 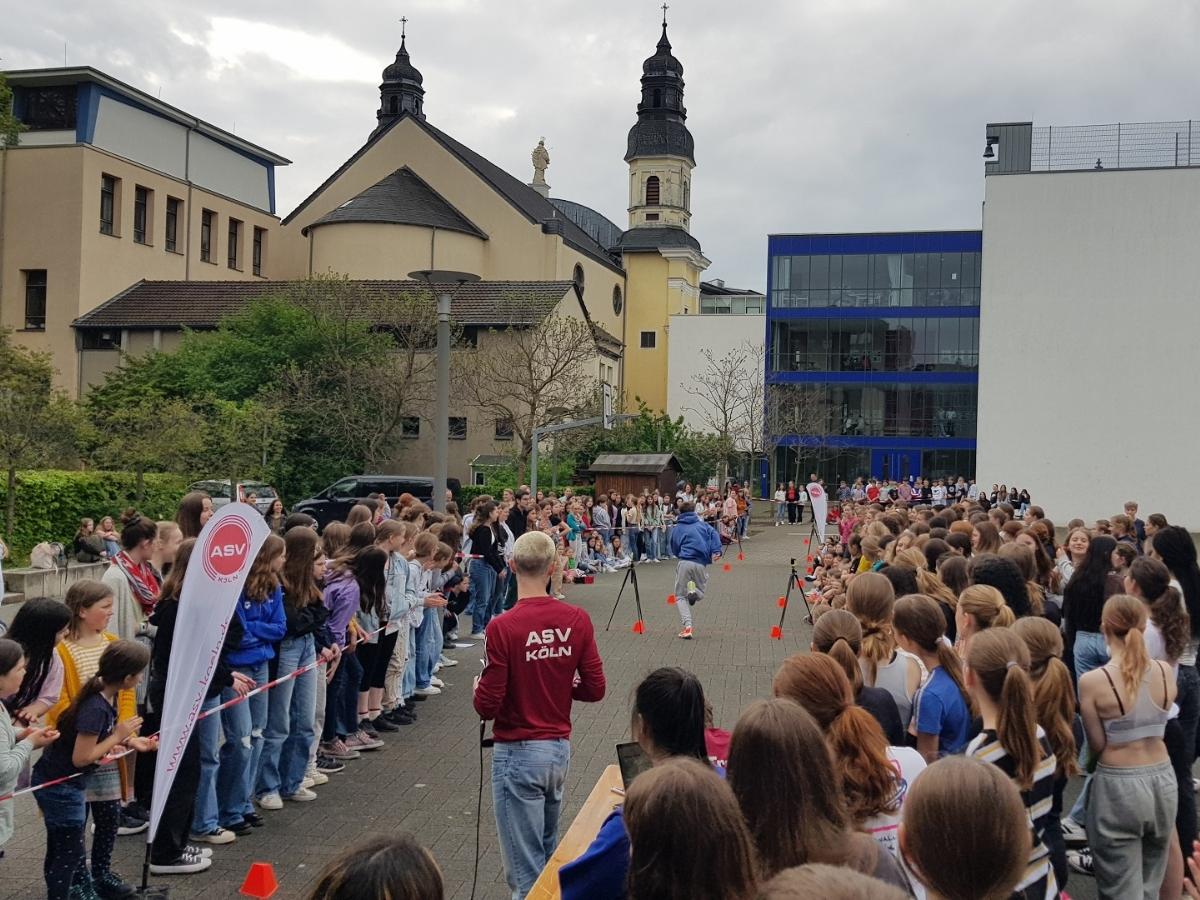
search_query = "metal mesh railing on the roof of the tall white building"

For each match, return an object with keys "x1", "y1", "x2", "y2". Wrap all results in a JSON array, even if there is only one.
[{"x1": 1030, "y1": 120, "x2": 1200, "y2": 172}]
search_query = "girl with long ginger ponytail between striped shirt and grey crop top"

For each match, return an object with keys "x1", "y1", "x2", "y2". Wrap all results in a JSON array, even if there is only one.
[{"x1": 1013, "y1": 616, "x2": 1079, "y2": 889}]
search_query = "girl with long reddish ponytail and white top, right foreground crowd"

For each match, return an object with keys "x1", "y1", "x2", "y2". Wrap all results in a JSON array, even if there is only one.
[{"x1": 774, "y1": 652, "x2": 925, "y2": 856}]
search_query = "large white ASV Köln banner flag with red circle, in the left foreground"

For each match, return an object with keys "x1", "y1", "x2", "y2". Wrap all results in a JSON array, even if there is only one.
[{"x1": 146, "y1": 503, "x2": 270, "y2": 844}]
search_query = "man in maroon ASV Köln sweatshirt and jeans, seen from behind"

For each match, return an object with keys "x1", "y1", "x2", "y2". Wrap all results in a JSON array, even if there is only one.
[{"x1": 475, "y1": 532, "x2": 605, "y2": 900}]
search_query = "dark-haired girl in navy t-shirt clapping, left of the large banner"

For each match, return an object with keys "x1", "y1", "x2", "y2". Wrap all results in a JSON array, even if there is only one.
[{"x1": 34, "y1": 641, "x2": 157, "y2": 900}]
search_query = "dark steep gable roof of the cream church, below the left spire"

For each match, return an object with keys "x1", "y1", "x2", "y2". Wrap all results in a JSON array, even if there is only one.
[{"x1": 283, "y1": 113, "x2": 624, "y2": 274}]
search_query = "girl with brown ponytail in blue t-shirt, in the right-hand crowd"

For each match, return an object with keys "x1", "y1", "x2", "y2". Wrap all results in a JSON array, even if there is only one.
[{"x1": 893, "y1": 594, "x2": 973, "y2": 762}]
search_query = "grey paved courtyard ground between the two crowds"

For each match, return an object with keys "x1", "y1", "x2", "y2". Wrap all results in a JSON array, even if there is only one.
[{"x1": 0, "y1": 524, "x2": 1094, "y2": 900}]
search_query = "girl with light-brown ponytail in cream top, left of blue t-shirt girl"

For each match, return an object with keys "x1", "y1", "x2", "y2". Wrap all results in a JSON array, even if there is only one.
[{"x1": 846, "y1": 572, "x2": 921, "y2": 730}]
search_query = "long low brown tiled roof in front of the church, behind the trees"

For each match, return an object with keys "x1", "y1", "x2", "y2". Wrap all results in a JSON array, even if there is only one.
[{"x1": 72, "y1": 281, "x2": 575, "y2": 329}]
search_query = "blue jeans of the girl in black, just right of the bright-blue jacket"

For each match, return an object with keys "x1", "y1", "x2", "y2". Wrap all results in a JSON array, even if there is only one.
[{"x1": 256, "y1": 635, "x2": 318, "y2": 797}]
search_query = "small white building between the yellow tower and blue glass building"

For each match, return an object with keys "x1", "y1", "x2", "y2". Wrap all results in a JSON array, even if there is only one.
[{"x1": 667, "y1": 280, "x2": 767, "y2": 441}]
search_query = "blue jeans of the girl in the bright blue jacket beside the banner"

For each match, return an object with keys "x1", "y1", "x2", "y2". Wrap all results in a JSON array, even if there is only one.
[{"x1": 217, "y1": 662, "x2": 270, "y2": 828}]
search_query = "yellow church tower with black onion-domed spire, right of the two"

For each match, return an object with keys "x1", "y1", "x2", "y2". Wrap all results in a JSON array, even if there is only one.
[{"x1": 618, "y1": 5, "x2": 709, "y2": 412}]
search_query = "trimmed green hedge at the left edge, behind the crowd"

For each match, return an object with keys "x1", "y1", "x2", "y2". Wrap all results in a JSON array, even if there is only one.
[{"x1": 0, "y1": 469, "x2": 192, "y2": 565}]
